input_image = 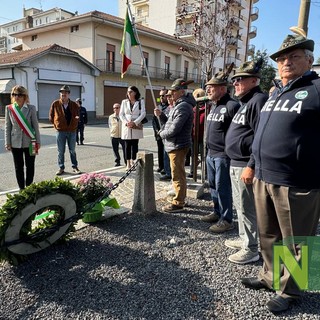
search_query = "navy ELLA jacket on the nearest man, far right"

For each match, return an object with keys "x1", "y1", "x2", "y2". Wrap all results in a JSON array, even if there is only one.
[{"x1": 253, "y1": 72, "x2": 320, "y2": 189}]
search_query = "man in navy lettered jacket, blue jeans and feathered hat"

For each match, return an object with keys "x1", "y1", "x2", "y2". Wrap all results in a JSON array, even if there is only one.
[{"x1": 201, "y1": 71, "x2": 240, "y2": 232}]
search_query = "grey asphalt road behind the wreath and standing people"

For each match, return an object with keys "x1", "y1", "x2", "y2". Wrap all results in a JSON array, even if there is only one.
[{"x1": 0, "y1": 123, "x2": 157, "y2": 194}]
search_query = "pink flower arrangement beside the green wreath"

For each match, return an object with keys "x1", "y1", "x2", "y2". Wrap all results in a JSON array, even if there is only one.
[{"x1": 78, "y1": 173, "x2": 113, "y2": 202}]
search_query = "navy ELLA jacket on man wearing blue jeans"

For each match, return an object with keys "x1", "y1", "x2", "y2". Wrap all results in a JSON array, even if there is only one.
[{"x1": 206, "y1": 93, "x2": 240, "y2": 158}]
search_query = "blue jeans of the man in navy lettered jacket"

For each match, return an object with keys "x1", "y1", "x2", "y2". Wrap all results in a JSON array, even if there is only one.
[{"x1": 206, "y1": 155, "x2": 233, "y2": 223}]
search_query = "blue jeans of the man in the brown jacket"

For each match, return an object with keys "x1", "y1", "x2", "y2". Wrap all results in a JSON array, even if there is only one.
[{"x1": 57, "y1": 131, "x2": 78, "y2": 170}]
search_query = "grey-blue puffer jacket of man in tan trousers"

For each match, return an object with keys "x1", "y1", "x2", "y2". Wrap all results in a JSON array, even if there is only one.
[{"x1": 160, "y1": 93, "x2": 196, "y2": 152}]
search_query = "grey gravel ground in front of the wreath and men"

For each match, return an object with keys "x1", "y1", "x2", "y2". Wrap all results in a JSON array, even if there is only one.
[{"x1": 0, "y1": 193, "x2": 320, "y2": 320}]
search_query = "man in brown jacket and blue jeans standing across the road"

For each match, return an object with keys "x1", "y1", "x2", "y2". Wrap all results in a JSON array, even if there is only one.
[{"x1": 49, "y1": 85, "x2": 81, "y2": 176}]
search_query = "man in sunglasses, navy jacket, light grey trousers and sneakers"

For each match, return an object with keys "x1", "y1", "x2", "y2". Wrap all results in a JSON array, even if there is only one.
[{"x1": 225, "y1": 59, "x2": 268, "y2": 264}]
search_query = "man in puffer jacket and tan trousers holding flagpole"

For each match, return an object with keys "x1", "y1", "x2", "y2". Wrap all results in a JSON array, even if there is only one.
[{"x1": 159, "y1": 79, "x2": 196, "y2": 212}]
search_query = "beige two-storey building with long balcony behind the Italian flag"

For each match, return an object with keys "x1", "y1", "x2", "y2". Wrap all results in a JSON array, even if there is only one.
[{"x1": 6, "y1": 11, "x2": 199, "y2": 116}]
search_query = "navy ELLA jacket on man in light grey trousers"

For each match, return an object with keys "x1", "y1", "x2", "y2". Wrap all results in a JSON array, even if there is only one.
[{"x1": 226, "y1": 86, "x2": 268, "y2": 168}]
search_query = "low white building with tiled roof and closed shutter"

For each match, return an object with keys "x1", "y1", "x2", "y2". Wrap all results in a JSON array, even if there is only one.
[{"x1": 0, "y1": 44, "x2": 100, "y2": 119}]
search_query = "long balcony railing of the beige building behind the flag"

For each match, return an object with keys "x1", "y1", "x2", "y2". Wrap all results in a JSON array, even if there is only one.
[{"x1": 96, "y1": 59, "x2": 200, "y2": 82}]
